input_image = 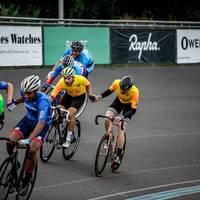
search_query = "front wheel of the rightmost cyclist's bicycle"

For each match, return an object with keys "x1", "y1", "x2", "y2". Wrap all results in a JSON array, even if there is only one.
[{"x1": 95, "y1": 134, "x2": 110, "y2": 176}]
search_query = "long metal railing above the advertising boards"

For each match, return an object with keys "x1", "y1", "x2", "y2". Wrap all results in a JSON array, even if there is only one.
[{"x1": 0, "y1": 16, "x2": 200, "y2": 28}]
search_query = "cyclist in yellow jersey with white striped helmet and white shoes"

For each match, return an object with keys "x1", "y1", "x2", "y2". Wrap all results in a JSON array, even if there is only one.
[{"x1": 49, "y1": 68, "x2": 92, "y2": 148}]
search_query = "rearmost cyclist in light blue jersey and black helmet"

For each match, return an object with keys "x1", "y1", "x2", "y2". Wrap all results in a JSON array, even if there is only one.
[{"x1": 53, "y1": 41, "x2": 94, "y2": 74}]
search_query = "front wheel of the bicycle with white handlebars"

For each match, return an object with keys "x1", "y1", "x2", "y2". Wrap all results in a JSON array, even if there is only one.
[{"x1": 40, "y1": 124, "x2": 57, "y2": 162}]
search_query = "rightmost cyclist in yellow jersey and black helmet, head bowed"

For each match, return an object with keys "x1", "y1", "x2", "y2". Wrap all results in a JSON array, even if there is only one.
[{"x1": 91, "y1": 76, "x2": 139, "y2": 163}]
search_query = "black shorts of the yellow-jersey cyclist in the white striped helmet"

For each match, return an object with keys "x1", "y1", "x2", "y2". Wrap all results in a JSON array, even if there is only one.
[{"x1": 59, "y1": 93, "x2": 85, "y2": 110}]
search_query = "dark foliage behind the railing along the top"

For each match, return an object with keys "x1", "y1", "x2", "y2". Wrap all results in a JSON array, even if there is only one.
[{"x1": 0, "y1": 0, "x2": 200, "y2": 21}]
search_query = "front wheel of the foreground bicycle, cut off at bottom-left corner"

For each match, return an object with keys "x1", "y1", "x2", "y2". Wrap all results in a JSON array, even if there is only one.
[{"x1": 0, "y1": 157, "x2": 14, "y2": 200}]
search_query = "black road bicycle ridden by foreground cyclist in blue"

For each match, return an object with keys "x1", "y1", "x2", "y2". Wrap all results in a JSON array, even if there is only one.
[{"x1": 0, "y1": 137, "x2": 38, "y2": 200}]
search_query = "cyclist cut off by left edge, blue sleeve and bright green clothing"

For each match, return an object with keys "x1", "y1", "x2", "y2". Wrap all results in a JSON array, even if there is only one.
[{"x1": 0, "y1": 81, "x2": 16, "y2": 129}]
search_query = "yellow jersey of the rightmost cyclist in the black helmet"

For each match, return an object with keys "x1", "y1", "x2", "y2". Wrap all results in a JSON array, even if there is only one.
[{"x1": 109, "y1": 79, "x2": 139, "y2": 108}]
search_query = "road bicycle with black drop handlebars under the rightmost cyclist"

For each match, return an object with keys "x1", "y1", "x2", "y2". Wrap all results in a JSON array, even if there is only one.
[{"x1": 95, "y1": 115, "x2": 126, "y2": 176}]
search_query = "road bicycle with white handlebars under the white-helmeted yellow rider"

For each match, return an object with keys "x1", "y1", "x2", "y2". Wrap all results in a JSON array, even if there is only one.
[{"x1": 40, "y1": 106, "x2": 81, "y2": 162}]
